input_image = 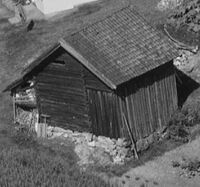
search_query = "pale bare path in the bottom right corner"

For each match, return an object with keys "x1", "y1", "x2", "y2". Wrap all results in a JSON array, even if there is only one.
[{"x1": 111, "y1": 137, "x2": 200, "y2": 187}]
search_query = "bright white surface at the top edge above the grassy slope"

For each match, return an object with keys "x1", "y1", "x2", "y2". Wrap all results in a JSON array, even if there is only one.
[{"x1": 34, "y1": 0, "x2": 96, "y2": 14}]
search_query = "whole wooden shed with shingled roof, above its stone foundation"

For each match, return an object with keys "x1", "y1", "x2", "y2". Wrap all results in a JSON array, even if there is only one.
[{"x1": 6, "y1": 6, "x2": 178, "y2": 139}]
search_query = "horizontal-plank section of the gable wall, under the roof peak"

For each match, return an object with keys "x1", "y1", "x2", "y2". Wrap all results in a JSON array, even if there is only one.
[{"x1": 36, "y1": 53, "x2": 91, "y2": 131}]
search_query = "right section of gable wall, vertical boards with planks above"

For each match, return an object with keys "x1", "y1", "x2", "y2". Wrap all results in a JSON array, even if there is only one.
[{"x1": 83, "y1": 67, "x2": 122, "y2": 138}]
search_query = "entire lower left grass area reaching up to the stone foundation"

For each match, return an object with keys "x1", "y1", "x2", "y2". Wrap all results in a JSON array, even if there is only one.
[{"x1": 0, "y1": 125, "x2": 109, "y2": 187}]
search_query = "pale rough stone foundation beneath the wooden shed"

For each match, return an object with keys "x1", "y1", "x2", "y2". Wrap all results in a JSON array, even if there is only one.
[{"x1": 47, "y1": 126, "x2": 169, "y2": 166}]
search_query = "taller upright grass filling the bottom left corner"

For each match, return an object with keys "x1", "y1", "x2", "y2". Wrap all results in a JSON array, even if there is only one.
[{"x1": 0, "y1": 146, "x2": 110, "y2": 187}]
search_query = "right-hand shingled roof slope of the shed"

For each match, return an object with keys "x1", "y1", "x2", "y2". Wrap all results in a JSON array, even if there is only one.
[{"x1": 62, "y1": 6, "x2": 178, "y2": 88}]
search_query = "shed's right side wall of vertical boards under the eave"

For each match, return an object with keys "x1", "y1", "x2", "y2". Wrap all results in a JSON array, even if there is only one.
[{"x1": 118, "y1": 63, "x2": 177, "y2": 139}]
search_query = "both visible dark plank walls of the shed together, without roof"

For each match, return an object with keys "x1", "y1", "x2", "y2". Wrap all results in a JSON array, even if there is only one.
[{"x1": 36, "y1": 47, "x2": 177, "y2": 139}]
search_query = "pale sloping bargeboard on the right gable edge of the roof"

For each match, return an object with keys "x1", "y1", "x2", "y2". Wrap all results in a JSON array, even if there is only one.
[{"x1": 59, "y1": 39, "x2": 116, "y2": 89}]
